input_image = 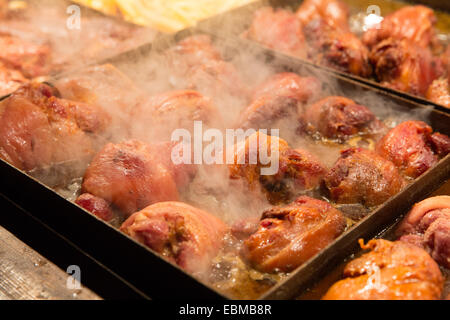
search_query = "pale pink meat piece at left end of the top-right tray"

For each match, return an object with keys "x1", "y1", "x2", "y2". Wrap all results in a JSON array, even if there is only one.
[{"x1": 245, "y1": 7, "x2": 307, "y2": 58}]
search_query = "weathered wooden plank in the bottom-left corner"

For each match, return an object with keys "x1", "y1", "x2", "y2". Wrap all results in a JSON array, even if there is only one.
[{"x1": 0, "y1": 226, "x2": 101, "y2": 300}]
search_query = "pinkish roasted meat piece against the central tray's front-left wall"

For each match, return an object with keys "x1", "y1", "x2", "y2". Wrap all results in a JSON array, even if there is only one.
[{"x1": 120, "y1": 202, "x2": 227, "y2": 273}]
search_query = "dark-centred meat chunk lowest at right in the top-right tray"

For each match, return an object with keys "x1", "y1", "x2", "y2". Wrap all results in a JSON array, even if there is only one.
[{"x1": 370, "y1": 38, "x2": 443, "y2": 95}]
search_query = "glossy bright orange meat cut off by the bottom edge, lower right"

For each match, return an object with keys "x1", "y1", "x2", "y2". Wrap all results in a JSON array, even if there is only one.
[{"x1": 323, "y1": 239, "x2": 444, "y2": 300}]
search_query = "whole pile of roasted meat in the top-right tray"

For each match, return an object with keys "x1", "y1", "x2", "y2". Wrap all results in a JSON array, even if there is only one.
[{"x1": 245, "y1": 0, "x2": 450, "y2": 108}]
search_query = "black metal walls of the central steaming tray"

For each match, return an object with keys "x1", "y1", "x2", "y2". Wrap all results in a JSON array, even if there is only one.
[{"x1": 0, "y1": 29, "x2": 450, "y2": 300}]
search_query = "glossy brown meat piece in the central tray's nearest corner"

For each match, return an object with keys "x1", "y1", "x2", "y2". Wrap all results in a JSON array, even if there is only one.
[{"x1": 241, "y1": 196, "x2": 346, "y2": 272}]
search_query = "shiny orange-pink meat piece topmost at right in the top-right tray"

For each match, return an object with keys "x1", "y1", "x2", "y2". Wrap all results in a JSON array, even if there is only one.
[{"x1": 363, "y1": 5, "x2": 436, "y2": 48}]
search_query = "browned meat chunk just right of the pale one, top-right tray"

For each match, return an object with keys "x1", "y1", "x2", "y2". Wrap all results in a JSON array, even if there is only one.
[{"x1": 303, "y1": 19, "x2": 372, "y2": 77}]
